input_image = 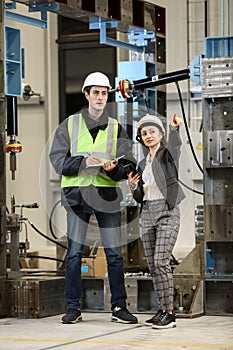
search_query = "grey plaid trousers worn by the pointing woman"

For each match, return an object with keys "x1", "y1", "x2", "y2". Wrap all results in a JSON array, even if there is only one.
[{"x1": 140, "y1": 200, "x2": 180, "y2": 310}]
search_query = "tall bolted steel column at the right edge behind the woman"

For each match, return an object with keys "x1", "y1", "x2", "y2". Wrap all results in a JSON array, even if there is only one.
[{"x1": 202, "y1": 56, "x2": 233, "y2": 315}]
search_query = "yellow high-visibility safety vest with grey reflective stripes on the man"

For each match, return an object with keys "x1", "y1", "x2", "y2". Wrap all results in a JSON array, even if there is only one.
[{"x1": 61, "y1": 114, "x2": 119, "y2": 188}]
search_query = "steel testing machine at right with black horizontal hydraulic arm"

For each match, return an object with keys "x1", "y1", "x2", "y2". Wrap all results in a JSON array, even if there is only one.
[{"x1": 115, "y1": 37, "x2": 233, "y2": 316}]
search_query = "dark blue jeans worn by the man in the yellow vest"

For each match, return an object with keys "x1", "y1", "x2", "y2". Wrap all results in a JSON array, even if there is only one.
[{"x1": 65, "y1": 209, "x2": 127, "y2": 309}]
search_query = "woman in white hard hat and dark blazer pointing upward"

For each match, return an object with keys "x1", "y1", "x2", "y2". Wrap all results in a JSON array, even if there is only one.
[{"x1": 128, "y1": 115, "x2": 184, "y2": 329}]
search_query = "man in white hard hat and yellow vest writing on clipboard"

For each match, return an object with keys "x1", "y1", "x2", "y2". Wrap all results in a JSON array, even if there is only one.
[{"x1": 50, "y1": 72, "x2": 137, "y2": 324}]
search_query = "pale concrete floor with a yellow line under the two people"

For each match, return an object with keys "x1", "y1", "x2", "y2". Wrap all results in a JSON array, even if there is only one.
[{"x1": 0, "y1": 312, "x2": 233, "y2": 350}]
